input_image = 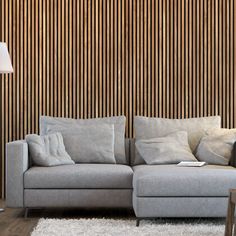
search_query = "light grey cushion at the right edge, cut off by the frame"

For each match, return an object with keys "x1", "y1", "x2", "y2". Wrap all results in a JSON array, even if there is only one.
[{"x1": 196, "y1": 129, "x2": 236, "y2": 165}]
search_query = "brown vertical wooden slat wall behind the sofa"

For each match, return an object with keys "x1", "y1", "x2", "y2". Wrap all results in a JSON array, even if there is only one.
[{"x1": 0, "y1": 0, "x2": 236, "y2": 197}]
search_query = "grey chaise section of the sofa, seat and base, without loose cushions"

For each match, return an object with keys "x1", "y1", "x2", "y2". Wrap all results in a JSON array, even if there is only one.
[{"x1": 133, "y1": 165, "x2": 236, "y2": 224}]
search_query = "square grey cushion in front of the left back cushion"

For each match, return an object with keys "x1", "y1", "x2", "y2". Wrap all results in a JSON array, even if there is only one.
[{"x1": 49, "y1": 124, "x2": 116, "y2": 164}]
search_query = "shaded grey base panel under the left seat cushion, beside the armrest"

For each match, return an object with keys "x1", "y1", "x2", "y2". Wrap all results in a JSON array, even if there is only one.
[{"x1": 24, "y1": 189, "x2": 132, "y2": 208}]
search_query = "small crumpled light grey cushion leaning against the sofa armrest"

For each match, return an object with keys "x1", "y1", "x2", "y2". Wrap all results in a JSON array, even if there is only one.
[{"x1": 25, "y1": 133, "x2": 74, "y2": 166}]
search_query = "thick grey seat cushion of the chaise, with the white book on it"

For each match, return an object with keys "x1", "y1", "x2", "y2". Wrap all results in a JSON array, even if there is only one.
[{"x1": 133, "y1": 165, "x2": 236, "y2": 197}]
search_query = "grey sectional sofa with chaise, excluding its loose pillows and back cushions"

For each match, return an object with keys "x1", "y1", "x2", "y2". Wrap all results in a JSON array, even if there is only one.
[{"x1": 6, "y1": 115, "x2": 236, "y2": 225}]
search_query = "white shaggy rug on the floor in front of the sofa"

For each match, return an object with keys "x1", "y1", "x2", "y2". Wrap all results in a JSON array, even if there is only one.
[{"x1": 32, "y1": 219, "x2": 224, "y2": 236}]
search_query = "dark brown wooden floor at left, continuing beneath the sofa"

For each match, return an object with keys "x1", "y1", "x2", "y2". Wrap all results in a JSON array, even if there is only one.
[{"x1": 0, "y1": 200, "x2": 135, "y2": 236}]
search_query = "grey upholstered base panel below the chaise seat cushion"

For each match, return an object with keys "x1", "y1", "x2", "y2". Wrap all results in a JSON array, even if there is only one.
[{"x1": 133, "y1": 196, "x2": 228, "y2": 217}]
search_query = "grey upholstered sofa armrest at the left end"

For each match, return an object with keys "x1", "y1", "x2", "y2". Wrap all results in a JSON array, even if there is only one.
[{"x1": 6, "y1": 140, "x2": 29, "y2": 207}]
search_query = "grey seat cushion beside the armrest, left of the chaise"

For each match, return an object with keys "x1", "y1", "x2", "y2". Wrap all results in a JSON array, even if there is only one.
[{"x1": 24, "y1": 164, "x2": 133, "y2": 189}]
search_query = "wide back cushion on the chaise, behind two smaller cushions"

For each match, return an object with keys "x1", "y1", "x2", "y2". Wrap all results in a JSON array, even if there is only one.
[{"x1": 134, "y1": 116, "x2": 221, "y2": 165}]
